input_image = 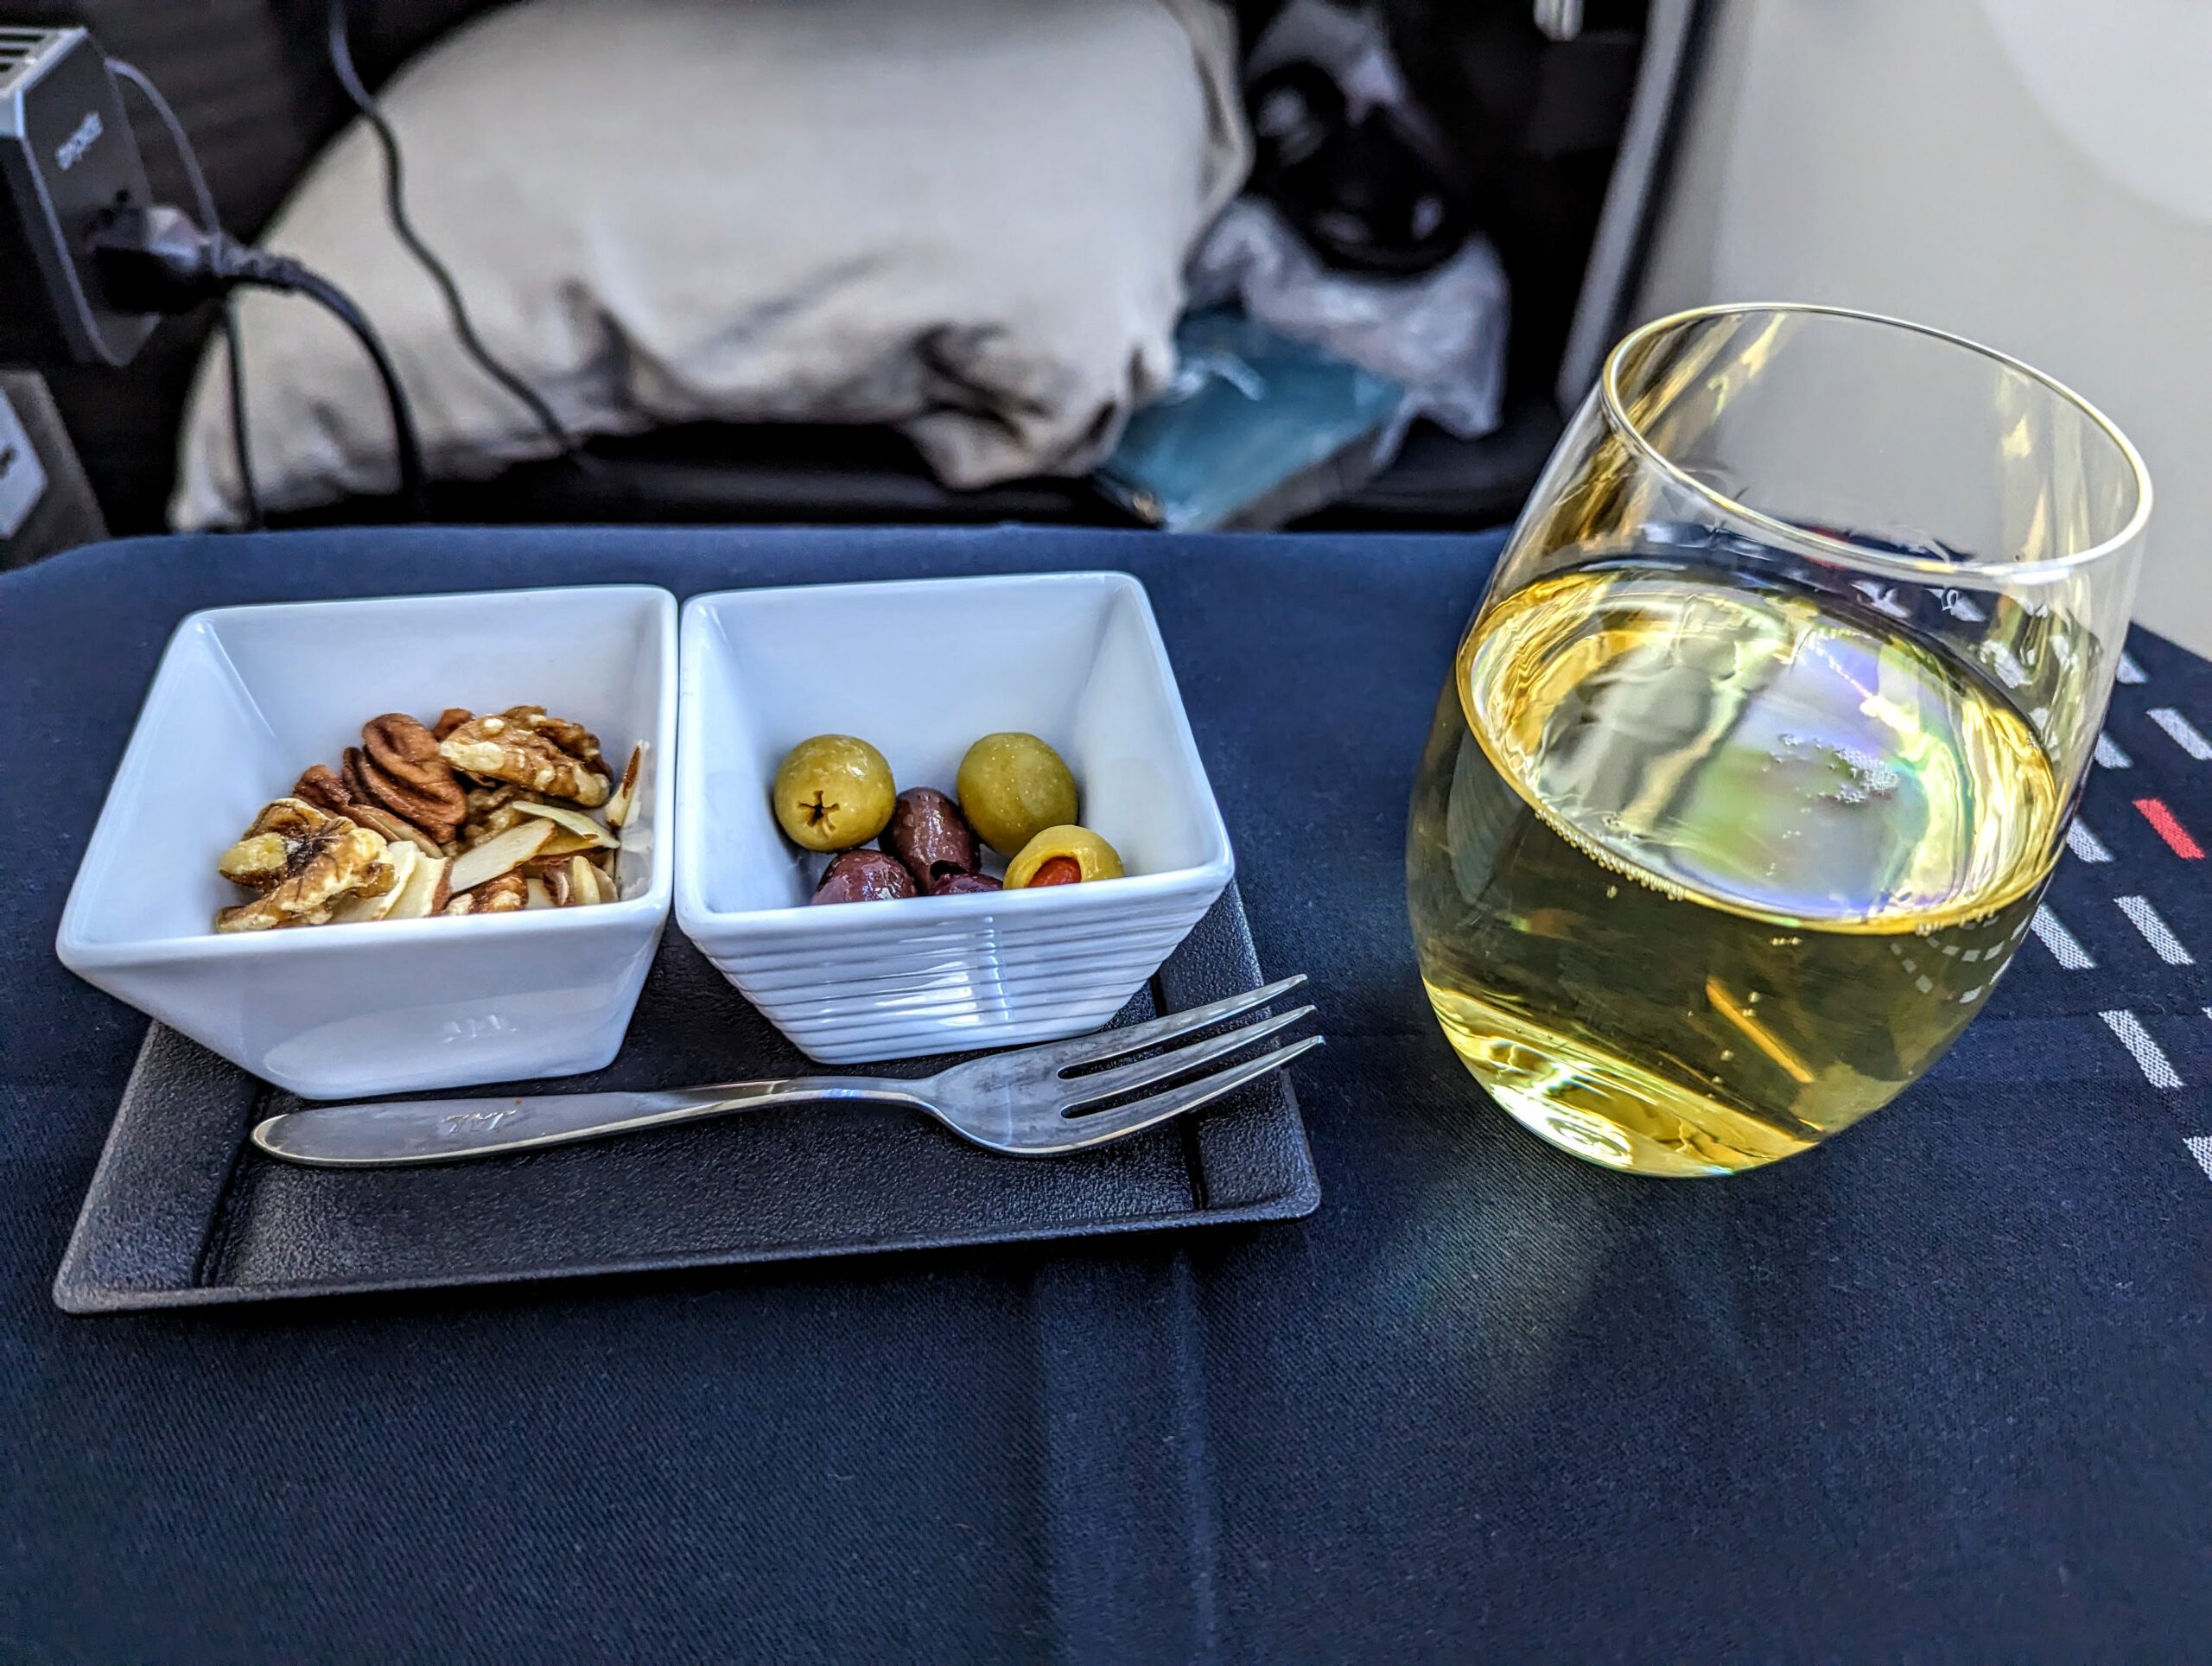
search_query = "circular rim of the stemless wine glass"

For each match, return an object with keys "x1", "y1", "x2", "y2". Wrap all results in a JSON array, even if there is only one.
[{"x1": 1597, "y1": 301, "x2": 2150, "y2": 584}]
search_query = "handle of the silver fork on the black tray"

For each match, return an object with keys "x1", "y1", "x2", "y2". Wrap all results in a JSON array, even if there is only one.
[{"x1": 254, "y1": 1075, "x2": 918, "y2": 1168}]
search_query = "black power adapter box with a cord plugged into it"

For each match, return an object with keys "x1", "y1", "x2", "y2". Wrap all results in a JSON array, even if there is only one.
[{"x1": 0, "y1": 27, "x2": 159, "y2": 365}]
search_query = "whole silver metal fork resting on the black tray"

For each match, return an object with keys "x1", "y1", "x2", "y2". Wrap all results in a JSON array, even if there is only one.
[{"x1": 254, "y1": 971, "x2": 1320, "y2": 1168}]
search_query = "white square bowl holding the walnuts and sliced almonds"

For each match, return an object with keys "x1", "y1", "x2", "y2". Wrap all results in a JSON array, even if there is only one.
[{"x1": 55, "y1": 584, "x2": 677, "y2": 1100}]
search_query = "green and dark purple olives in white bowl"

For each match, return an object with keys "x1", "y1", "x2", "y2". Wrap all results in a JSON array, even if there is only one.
[{"x1": 770, "y1": 733, "x2": 1123, "y2": 903}]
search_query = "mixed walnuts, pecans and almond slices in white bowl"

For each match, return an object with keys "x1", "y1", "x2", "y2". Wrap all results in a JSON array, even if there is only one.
[{"x1": 214, "y1": 706, "x2": 646, "y2": 932}]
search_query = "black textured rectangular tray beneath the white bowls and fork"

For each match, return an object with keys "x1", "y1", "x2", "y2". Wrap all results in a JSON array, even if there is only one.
[{"x1": 53, "y1": 885, "x2": 1320, "y2": 1314}]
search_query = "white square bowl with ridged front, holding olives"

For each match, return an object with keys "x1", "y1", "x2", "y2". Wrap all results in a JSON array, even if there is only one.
[{"x1": 677, "y1": 573, "x2": 1234, "y2": 1065}]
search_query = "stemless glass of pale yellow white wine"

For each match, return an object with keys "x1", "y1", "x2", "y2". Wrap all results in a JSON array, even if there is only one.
[{"x1": 1407, "y1": 305, "x2": 2150, "y2": 1175}]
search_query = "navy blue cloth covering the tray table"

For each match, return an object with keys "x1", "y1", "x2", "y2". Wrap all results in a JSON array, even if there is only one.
[{"x1": 0, "y1": 529, "x2": 2212, "y2": 1662}]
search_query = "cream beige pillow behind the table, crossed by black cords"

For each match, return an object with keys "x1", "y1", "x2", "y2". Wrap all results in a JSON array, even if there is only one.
[{"x1": 173, "y1": 0, "x2": 1248, "y2": 526}]
